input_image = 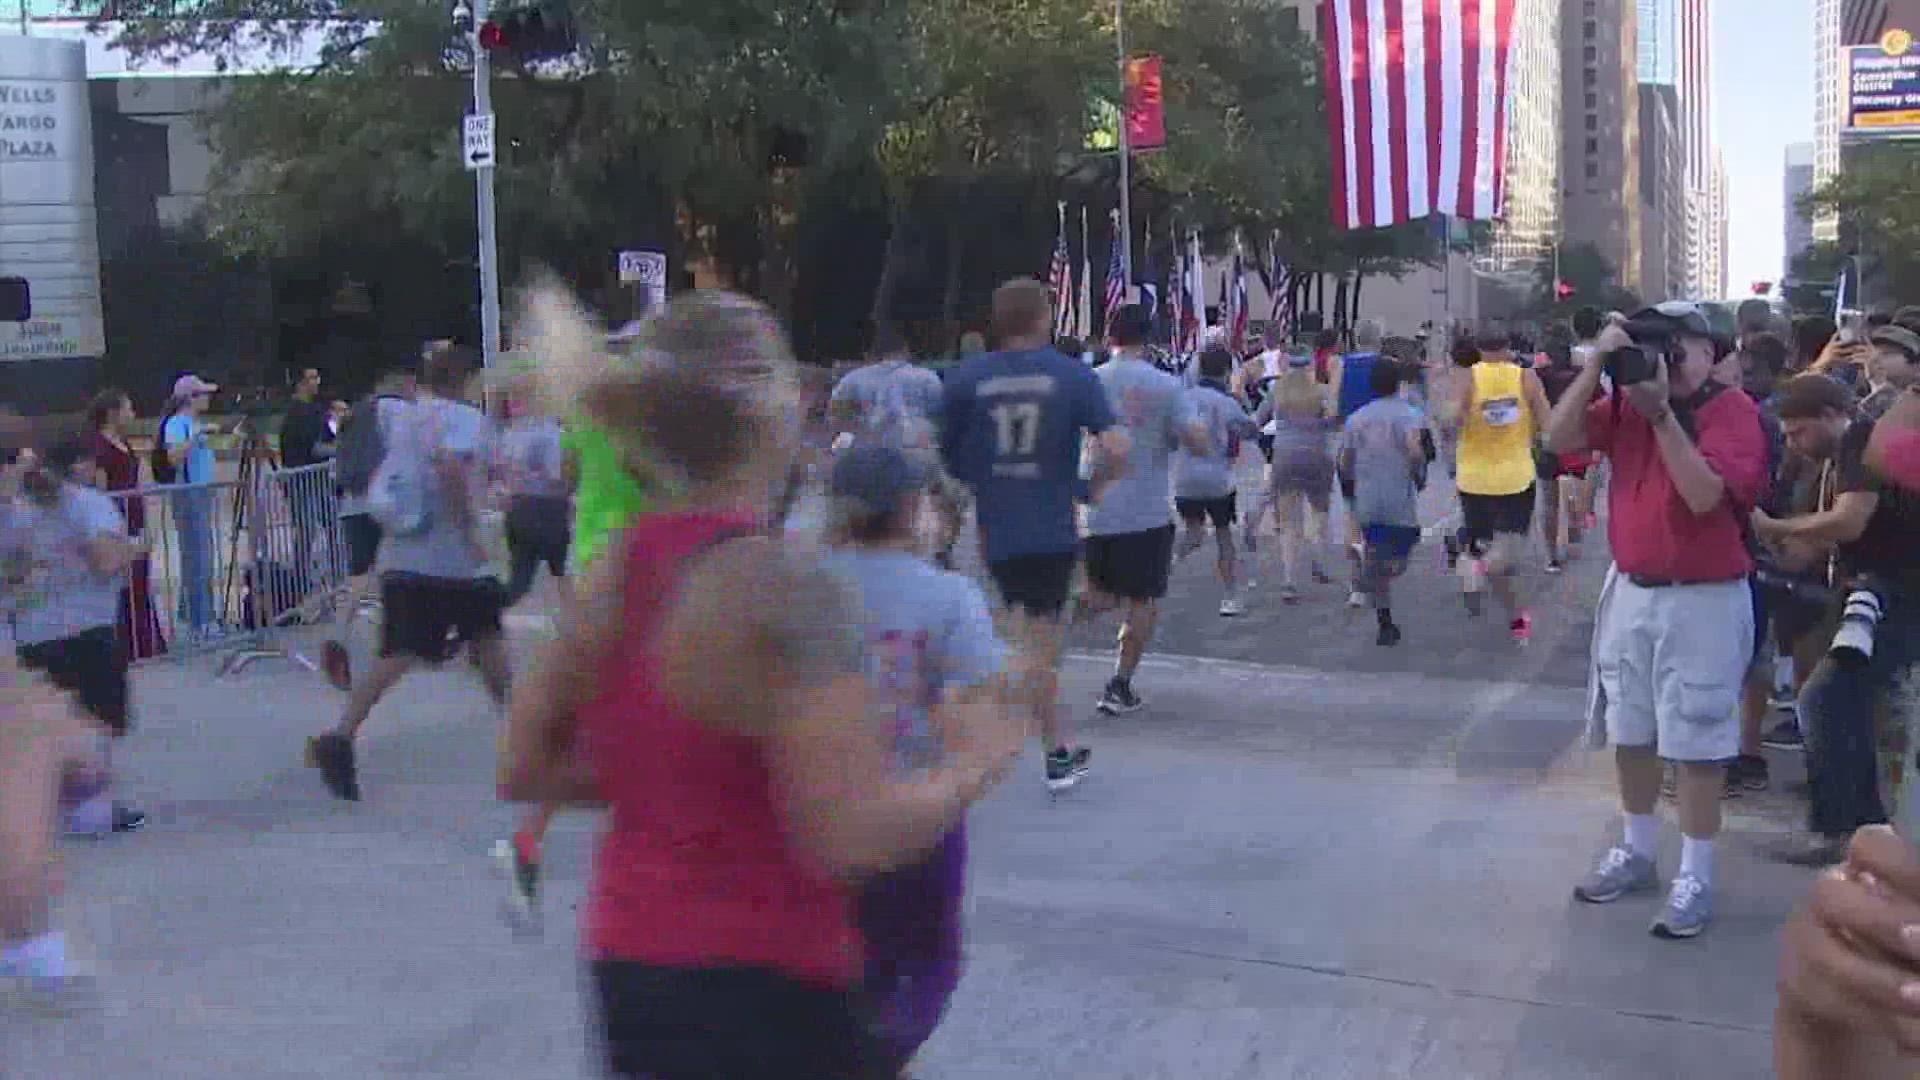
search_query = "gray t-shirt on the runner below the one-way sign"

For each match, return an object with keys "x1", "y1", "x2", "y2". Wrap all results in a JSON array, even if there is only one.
[{"x1": 380, "y1": 398, "x2": 495, "y2": 580}]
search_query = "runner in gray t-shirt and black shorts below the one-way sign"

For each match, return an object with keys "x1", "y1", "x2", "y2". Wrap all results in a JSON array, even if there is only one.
[{"x1": 307, "y1": 346, "x2": 509, "y2": 801}]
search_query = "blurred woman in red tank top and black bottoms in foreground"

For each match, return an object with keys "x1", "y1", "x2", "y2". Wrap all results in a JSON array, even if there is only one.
[{"x1": 501, "y1": 294, "x2": 1023, "y2": 1080}]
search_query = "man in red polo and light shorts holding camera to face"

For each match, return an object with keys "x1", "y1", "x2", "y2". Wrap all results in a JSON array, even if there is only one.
[{"x1": 1548, "y1": 302, "x2": 1766, "y2": 938}]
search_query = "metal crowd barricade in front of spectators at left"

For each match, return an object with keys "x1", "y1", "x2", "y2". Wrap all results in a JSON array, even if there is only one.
[{"x1": 113, "y1": 463, "x2": 348, "y2": 676}]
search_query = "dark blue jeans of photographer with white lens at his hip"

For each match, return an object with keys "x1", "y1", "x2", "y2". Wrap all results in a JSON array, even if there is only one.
[{"x1": 1799, "y1": 594, "x2": 1920, "y2": 836}]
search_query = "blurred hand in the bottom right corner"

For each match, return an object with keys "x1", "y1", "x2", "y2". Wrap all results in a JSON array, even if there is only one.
[{"x1": 1780, "y1": 824, "x2": 1920, "y2": 1053}]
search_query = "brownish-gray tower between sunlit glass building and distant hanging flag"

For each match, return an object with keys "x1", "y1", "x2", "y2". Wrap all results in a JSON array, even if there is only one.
[{"x1": 1561, "y1": 0, "x2": 1642, "y2": 292}]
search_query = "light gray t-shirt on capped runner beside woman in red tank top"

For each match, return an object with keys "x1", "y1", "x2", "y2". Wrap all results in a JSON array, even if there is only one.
[{"x1": 828, "y1": 550, "x2": 1006, "y2": 769}]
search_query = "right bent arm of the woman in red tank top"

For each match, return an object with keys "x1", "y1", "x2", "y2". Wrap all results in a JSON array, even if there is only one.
[{"x1": 657, "y1": 538, "x2": 1021, "y2": 878}]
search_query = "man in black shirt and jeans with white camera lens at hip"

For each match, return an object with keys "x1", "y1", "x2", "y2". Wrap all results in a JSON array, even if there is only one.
[{"x1": 1753, "y1": 375, "x2": 1920, "y2": 867}]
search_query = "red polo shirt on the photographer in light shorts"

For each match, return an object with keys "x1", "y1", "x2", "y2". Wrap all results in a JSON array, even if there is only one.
[{"x1": 1586, "y1": 390, "x2": 1768, "y2": 582}]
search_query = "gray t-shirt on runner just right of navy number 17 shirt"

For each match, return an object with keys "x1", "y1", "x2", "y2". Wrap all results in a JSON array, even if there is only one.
[{"x1": 1087, "y1": 357, "x2": 1196, "y2": 536}]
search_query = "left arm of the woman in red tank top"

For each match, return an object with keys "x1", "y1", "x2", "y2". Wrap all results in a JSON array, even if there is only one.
[{"x1": 499, "y1": 538, "x2": 626, "y2": 803}]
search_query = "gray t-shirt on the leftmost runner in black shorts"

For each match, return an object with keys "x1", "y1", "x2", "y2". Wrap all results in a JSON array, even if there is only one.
[{"x1": 0, "y1": 482, "x2": 127, "y2": 646}]
